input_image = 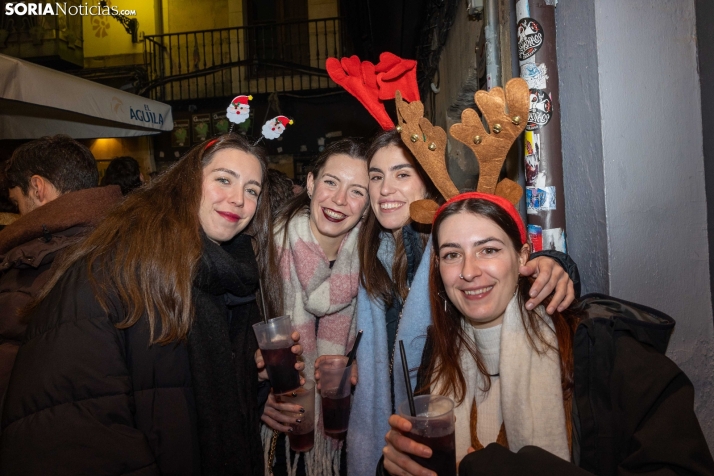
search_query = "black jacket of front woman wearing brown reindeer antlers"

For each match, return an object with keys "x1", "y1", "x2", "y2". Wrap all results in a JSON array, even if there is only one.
[{"x1": 459, "y1": 294, "x2": 714, "y2": 476}]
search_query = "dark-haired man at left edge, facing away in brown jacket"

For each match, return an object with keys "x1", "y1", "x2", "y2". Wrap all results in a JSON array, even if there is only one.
[{"x1": 0, "y1": 135, "x2": 121, "y2": 402}]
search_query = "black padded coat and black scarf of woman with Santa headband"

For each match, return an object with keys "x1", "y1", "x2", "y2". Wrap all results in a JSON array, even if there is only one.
[{"x1": 0, "y1": 235, "x2": 263, "y2": 476}]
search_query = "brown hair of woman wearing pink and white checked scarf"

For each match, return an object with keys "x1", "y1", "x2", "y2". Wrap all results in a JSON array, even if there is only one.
[{"x1": 265, "y1": 137, "x2": 366, "y2": 315}]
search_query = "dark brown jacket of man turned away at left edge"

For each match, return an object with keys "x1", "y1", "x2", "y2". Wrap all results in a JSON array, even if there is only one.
[{"x1": 0, "y1": 186, "x2": 122, "y2": 400}]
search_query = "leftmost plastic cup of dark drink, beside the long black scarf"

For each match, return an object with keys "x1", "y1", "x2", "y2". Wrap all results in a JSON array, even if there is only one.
[{"x1": 253, "y1": 316, "x2": 300, "y2": 394}]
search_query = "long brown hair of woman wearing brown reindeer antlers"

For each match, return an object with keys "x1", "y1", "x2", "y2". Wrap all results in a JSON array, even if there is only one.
[{"x1": 419, "y1": 199, "x2": 578, "y2": 403}]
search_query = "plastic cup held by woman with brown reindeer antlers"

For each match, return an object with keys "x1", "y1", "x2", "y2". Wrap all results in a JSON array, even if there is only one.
[{"x1": 398, "y1": 395, "x2": 456, "y2": 476}]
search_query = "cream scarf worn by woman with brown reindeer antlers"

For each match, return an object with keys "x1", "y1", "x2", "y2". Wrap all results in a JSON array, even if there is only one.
[{"x1": 434, "y1": 296, "x2": 570, "y2": 461}]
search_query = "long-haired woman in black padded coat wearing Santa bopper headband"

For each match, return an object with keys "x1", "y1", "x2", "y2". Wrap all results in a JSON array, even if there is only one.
[{"x1": 0, "y1": 134, "x2": 303, "y2": 476}]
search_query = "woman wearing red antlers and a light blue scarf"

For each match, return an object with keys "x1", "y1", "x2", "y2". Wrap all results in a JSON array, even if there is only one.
[{"x1": 327, "y1": 53, "x2": 577, "y2": 474}]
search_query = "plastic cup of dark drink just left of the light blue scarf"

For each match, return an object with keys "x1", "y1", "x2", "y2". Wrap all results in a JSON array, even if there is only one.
[{"x1": 320, "y1": 356, "x2": 354, "y2": 439}]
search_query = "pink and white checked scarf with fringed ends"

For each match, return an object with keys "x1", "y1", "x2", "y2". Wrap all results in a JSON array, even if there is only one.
[{"x1": 263, "y1": 210, "x2": 359, "y2": 476}]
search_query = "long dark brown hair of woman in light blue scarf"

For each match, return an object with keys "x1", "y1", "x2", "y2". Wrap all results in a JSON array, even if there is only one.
[{"x1": 358, "y1": 129, "x2": 440, "y2": 307}]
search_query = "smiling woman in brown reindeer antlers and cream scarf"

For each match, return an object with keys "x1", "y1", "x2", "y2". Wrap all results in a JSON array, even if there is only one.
[{"x1": 377, "y1": 79, "x2": 714, "y2": 476}]
